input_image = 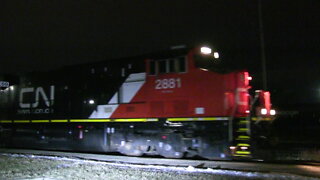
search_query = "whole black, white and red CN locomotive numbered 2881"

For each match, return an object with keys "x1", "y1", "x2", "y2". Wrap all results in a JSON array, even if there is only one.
[{"x1": 0, "y1": 47, "x2": 273, "y2": 159}]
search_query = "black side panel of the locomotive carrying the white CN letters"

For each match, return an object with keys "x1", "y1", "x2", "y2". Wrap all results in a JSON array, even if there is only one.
[{"x1": 1, "y1": 60, "x2": 143, "y2": 120}]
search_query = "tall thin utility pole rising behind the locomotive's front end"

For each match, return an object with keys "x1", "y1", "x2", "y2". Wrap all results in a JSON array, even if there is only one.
[{"x1": 258, "y1": 0, "x2": 268, "y2": 90}]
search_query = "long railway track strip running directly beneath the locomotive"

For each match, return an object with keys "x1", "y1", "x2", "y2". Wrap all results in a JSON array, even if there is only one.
[{"x1": 0, "y1": 148, "x2": 320, "y2": 178}]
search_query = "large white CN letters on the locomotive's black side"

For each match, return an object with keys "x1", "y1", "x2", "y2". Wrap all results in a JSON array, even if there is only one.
[{"x1": 19, "y1": 86, "x2": 54, "y2": 108}]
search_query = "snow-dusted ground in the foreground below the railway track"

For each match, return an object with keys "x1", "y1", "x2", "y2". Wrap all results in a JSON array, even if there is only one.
[{"x1": 0, "y1": 154, "x2": 315, "y2": 180}]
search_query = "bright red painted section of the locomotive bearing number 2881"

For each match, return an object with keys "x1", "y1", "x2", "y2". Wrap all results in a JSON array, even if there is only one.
[{"x1": 111, "y1": 47, "x2": 255, "y2": 118}]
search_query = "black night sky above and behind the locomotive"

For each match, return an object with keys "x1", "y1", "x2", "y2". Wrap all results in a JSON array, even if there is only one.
[{"x1": 0, "y1": 0, "x2": 320, "y2": 106}]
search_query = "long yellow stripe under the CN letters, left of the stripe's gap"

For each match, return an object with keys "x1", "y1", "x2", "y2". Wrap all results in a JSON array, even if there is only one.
[{"x1": 0, "y1": 118, "x2": 158, "y2": 123}]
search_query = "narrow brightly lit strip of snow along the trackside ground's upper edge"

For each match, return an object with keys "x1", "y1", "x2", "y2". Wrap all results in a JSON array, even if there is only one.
[{"x1": 1, "y1": 153, "x2": 314, "y2": 180}]
